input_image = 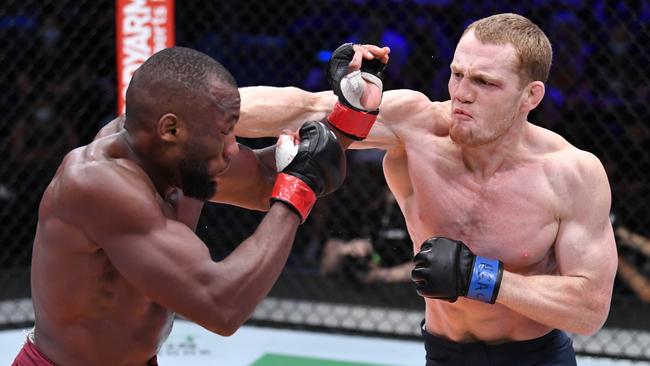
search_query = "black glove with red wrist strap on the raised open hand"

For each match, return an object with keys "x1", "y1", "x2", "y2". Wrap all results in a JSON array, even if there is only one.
[{"x1": 327, "y1": 43, "x2": 386, "y2": 140}]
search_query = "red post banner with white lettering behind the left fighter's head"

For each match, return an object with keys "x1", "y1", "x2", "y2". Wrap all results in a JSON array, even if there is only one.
[{"x1": 115, "y1": 0, "x2": 175, "y2": 114}]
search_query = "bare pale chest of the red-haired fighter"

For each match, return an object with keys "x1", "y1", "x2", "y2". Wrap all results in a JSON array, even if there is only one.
[{"x1": 384, "y1": 151, "x2": 559, "y2": 273}]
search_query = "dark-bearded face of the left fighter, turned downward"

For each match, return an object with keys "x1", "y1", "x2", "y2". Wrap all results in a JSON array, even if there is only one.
[{"x1": 179, "y1": 88, "x2": 239, "y2": 200}]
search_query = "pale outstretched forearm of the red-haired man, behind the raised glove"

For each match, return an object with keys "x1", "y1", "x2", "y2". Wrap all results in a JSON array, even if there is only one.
[{"x1": 235, "y1": 86, "x2": 336, "y2": 138}]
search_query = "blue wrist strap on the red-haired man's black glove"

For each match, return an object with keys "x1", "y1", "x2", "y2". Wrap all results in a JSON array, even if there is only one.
[{"x1": 467, "y1": 256, "x2": 503, "y2": 304}]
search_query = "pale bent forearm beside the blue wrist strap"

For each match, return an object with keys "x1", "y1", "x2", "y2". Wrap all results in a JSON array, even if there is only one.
[{"x1": 497, "y1": 271, "x2": 611, "y2": 335}]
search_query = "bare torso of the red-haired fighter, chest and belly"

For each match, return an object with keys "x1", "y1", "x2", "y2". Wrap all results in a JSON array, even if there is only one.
[{"x1": 384, "y1": 98, "x2": 571, "y2": 343}]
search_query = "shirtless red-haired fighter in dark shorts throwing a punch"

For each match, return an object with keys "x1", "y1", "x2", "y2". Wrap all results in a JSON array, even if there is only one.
[{"x1": 235, "y1": 14, "x2": 617, "y2": 366}]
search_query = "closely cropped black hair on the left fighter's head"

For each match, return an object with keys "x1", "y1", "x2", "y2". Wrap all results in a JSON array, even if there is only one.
[{"x1": 126, "y1": 47, "x2": 237, "y2": 121}]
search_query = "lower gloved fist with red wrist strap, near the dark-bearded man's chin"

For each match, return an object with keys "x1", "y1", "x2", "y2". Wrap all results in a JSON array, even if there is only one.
[{"x1": 271, "y1": 121, "x2": 346, "y2": 222}]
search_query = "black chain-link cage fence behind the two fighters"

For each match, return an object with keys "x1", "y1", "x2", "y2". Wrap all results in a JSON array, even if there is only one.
[{"x1": 0, "y1": 0, "x2": 650, "y2": 359}]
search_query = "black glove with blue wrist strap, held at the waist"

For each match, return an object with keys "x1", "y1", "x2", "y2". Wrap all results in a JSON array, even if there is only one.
[{"x1": 411, "y1": 237, "x2": 503, "y2": 304}]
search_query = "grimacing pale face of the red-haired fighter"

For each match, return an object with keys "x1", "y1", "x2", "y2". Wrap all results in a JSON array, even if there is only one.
[{"x1": 448, "y1": 31, "x2": 525, "y2": 146}]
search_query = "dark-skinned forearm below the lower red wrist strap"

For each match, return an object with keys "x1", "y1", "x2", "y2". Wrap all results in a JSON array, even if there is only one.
[{"x1": 202, "y1": 202, "x2": 300, "y2": 335}]
